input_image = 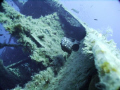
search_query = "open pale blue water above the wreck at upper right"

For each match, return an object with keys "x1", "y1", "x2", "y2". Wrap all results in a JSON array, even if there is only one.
[{"x1": 61, "y1": 0, "x2": 120, "y2": 49}]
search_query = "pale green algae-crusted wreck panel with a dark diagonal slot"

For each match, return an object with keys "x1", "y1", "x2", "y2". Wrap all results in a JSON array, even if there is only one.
[{"x1": 0, "y1": 0, "x2": 64, "y2": 66}]
